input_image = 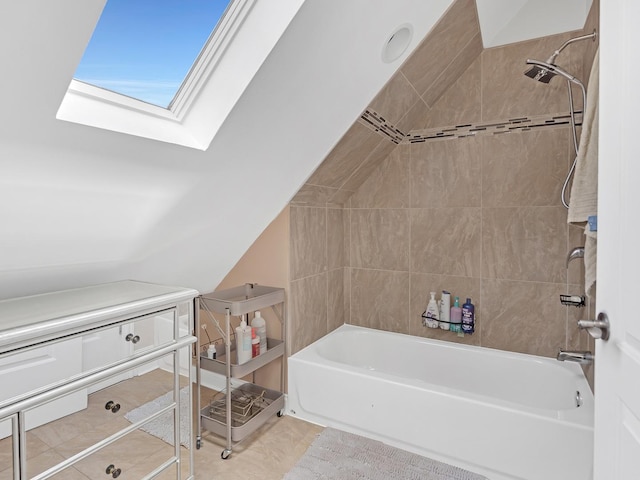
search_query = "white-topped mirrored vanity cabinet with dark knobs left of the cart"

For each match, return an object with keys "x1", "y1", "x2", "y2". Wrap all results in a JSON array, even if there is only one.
[{"x1": 0, "y1": 281, "x2": 198, "y2": 480}]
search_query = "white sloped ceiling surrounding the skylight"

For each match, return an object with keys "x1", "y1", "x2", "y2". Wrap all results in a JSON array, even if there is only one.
[{"x1": 0, "y1": 0, "x2": 592, "y2": 298}]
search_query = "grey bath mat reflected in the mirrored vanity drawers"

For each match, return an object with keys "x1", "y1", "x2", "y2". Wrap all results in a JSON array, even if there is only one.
[{"x1": 124, "y1": 387, "x2": 190, "y2": 448}]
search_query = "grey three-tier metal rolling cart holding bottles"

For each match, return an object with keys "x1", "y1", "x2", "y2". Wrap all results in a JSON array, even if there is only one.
[{"x1": 195, "y1": 283, "x2": 286, "y2": 459}]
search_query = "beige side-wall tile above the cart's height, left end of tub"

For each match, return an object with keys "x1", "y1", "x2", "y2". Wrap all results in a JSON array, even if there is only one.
[{"x1": 290, "y1": 205, "x2": 327, "y2": 280}]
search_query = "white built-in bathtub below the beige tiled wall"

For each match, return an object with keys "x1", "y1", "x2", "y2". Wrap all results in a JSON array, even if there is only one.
[{"x1": 287, "y1": 325, "x2": 593, "y2": 480}]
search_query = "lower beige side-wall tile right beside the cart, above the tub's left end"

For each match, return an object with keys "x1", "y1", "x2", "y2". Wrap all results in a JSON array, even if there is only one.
[{"x1": 289, "y1": 273, "x2": 327, "y2": 355}]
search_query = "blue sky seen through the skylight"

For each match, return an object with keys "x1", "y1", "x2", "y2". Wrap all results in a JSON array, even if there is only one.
[{"x1": 74, "y1": 0, "x2": 231, "y2": 108}]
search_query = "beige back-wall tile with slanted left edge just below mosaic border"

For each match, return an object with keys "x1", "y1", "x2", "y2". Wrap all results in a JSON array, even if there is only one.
[{"x1": 350, "y1": 145, "x2": 409, "y2": 208}]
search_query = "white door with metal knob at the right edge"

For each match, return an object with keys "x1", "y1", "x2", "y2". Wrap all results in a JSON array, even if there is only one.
[{"x1": 594, "y1": 0, "x2": 640, "y2": 480}]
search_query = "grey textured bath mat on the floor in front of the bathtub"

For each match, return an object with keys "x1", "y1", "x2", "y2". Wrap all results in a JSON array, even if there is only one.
[{"x1": 283, "y1": 428, "x2": 487, "y2": 480}]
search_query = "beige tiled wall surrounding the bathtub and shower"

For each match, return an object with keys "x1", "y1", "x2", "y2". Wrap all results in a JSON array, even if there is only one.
[{"x1": 290, "y1": 0, "x2": 598, "y2": 362}]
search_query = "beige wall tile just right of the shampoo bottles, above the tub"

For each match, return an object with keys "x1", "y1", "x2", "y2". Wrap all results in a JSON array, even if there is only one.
[{"x1": 481, "y1": 280, "x2": 566, "y2": 357}]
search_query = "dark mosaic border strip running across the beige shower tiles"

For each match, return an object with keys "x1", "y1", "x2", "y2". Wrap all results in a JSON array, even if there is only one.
[{"x1": 360, "y1": 110, "x2": 582, "y2": 144}]
